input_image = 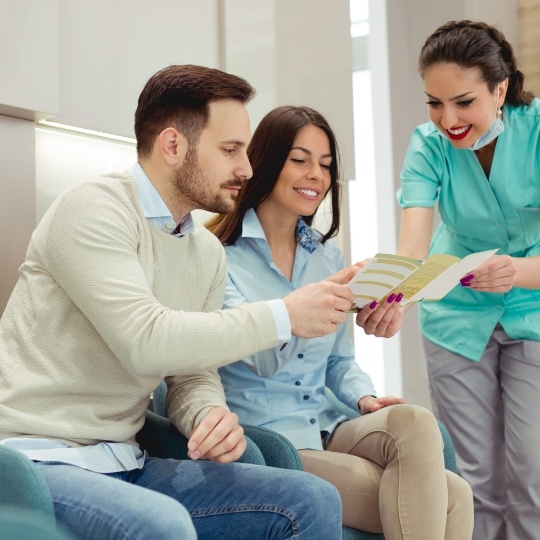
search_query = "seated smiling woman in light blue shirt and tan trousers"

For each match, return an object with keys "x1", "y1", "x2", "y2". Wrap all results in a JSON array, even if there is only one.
[{"x1": 208, "y1": 106, "x2": 472, "y2": 540}]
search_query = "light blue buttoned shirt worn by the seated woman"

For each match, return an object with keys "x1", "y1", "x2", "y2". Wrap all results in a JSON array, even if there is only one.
[{"x1": 219, "y1": 209, "x2": 375, "y2": 449}]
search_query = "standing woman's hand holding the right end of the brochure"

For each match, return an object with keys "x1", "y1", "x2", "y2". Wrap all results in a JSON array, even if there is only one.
[{"x1": 461, "y1": 255, "x2": 517, "y2": 292}]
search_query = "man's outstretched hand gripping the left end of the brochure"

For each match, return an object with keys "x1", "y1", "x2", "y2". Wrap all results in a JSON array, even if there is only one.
[{"x1": 283, "y1": 281, "x2": 353, "y2": 338}]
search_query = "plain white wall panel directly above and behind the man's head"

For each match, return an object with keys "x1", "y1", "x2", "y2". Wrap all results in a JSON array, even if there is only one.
[{"x1": 56, "y1": 0, "x2": 219, "y2": 137}]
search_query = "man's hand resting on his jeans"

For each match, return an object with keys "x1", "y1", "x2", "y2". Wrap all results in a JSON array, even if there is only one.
[{"x1": 188, "y1": 407, "x2": 246, "y2": 463}]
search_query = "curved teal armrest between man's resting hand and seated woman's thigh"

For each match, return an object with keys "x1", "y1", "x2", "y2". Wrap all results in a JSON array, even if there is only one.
[{"x1": 243, "y1": 424, "x2": 303, "y2": 471}]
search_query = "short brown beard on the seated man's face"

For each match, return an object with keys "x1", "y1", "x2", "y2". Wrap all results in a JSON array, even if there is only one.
[{"x1": 174, "y1": 147, "x2": 241, "y2": 214}]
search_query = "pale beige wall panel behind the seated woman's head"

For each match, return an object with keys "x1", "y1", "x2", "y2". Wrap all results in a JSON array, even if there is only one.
[{"x1": 224, "y1": 0, "x2": 354, "y2": 258}]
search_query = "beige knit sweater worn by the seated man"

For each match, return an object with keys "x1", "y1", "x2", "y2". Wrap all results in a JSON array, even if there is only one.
[{"x1": 0, "y1": 174, "x2": 277, "y2": 446}]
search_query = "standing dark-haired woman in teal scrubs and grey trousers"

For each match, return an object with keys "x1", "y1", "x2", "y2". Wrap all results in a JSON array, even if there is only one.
[{"x1": 392, "y1": 21, "x2": 540, "y2": 540}]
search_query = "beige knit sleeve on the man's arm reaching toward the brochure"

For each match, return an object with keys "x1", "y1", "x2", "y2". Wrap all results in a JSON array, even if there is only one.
[{"x1": 41, "y1": 182, "x2": 277, "y2": 378}]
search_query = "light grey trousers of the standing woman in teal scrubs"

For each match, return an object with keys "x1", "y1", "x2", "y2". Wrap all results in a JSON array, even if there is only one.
[{"x1": 424, "y1": 325, "x2": 540, "y2": 540}]
